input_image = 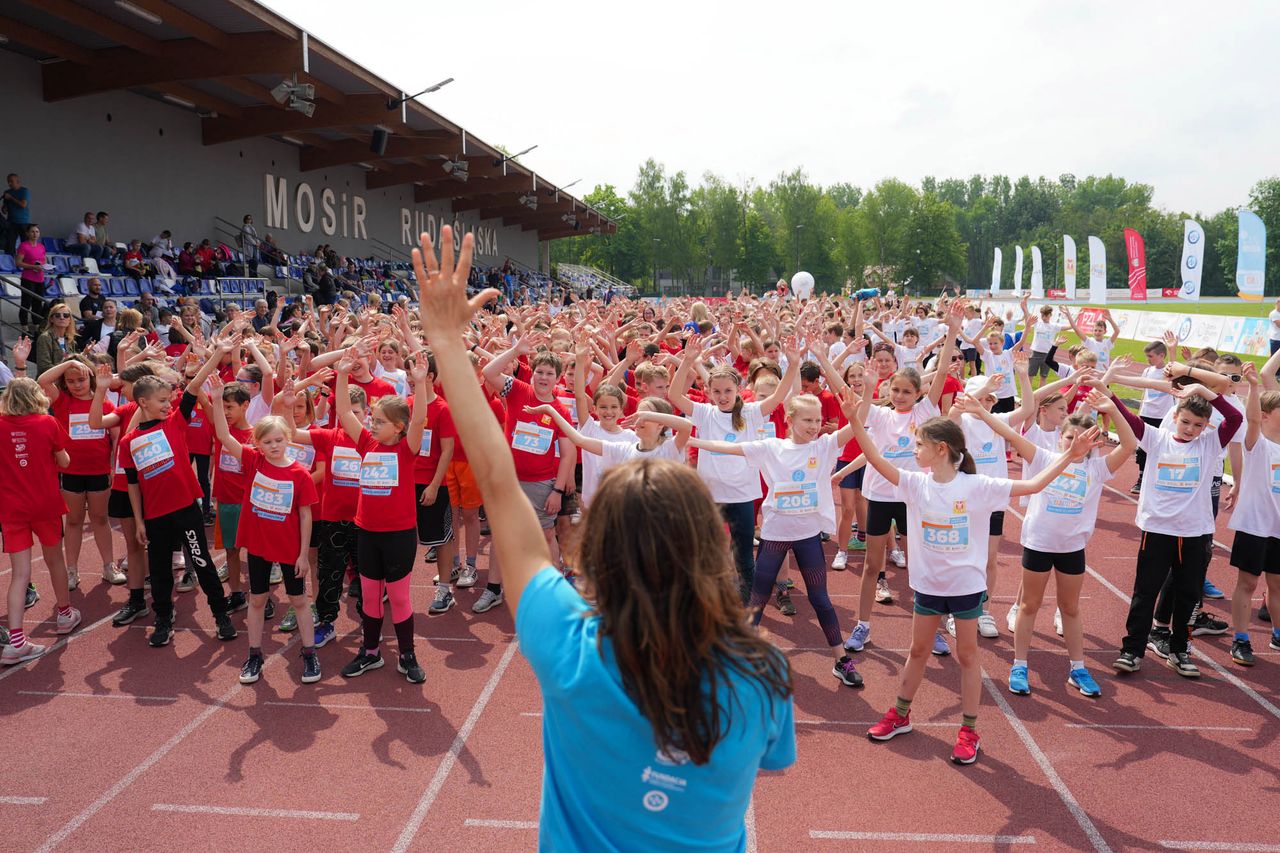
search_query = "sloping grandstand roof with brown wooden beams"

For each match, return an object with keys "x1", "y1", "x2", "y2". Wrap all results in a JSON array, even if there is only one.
[{"x1": 0, "y1": 0, "x2": 617, "y2": 240}]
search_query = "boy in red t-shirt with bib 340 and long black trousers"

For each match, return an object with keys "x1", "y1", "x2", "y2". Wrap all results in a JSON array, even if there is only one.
[{"x1": 120, "y1": 345, "x2": 236, "y2": 647}]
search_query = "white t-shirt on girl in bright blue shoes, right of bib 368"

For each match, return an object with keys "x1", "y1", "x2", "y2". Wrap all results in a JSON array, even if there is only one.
[{"x1": 1021, "y1": 447, "x2": 1115, "y2": 553}]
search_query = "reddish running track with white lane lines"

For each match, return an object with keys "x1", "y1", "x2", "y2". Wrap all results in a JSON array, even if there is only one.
[{"x1": 0, "y1": 455, "x2": 1280, "y2": 852}]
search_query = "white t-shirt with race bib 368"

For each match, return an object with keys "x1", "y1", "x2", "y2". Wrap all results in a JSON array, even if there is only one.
[{"x1": 895, "y1": 471, "x2": 1012, "y2": 596}]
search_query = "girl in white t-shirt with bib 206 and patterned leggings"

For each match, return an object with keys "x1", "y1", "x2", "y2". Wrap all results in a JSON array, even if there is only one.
[{"x1": 689, "y1": 391, "x2": 863, "y2": 686}]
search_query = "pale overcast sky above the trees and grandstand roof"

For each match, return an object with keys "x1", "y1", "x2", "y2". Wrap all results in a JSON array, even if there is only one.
[{"x1": 259, "y1": 0, "x2": 1280, "y2": 214}]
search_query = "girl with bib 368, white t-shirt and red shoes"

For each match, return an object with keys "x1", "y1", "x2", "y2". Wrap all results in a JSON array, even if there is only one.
[{"x1": 850, "y1": 407, "x2": 1101, "y2": 765}]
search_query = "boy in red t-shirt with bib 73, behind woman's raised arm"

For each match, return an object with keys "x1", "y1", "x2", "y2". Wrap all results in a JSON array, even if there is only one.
[{"x1": 481, "y1": 338, "x2": 577, "y2": 613}]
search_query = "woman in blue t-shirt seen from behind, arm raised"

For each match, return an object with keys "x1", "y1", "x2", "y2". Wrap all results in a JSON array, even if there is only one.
[{"x1": 413, "y1": 227, "x2": 795, "y2": 850}]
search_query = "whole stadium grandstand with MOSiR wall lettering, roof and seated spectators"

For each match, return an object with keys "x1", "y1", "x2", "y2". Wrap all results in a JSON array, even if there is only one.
[{"x1": 0, "y1": 0, "x2": 616, "y2": 351}]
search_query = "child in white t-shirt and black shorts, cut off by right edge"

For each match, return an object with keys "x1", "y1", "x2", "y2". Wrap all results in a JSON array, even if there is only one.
[{"x1": 1228, "y1": 362, "x2": 1280, "y2": 666}]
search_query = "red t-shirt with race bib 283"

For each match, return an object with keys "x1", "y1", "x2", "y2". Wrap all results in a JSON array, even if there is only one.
[{"x1": 236, "y1": 447, "x2": 317, "y2": 565}]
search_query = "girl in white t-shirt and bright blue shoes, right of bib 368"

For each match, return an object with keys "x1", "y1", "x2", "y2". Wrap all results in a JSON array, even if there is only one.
[{"x1": 962, "y1": 391, "x2": 1138, "y2": 697}]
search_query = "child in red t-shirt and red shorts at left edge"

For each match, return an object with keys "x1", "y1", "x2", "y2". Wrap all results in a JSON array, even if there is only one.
[{"x1": 0, "y1": 377, "x2": 81, "y2": 666}]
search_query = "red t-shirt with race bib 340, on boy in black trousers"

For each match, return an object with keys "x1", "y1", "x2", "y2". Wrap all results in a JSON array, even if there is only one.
[{"x1": 120, "y1": 406, "x2": 202, "y2": 519}]
